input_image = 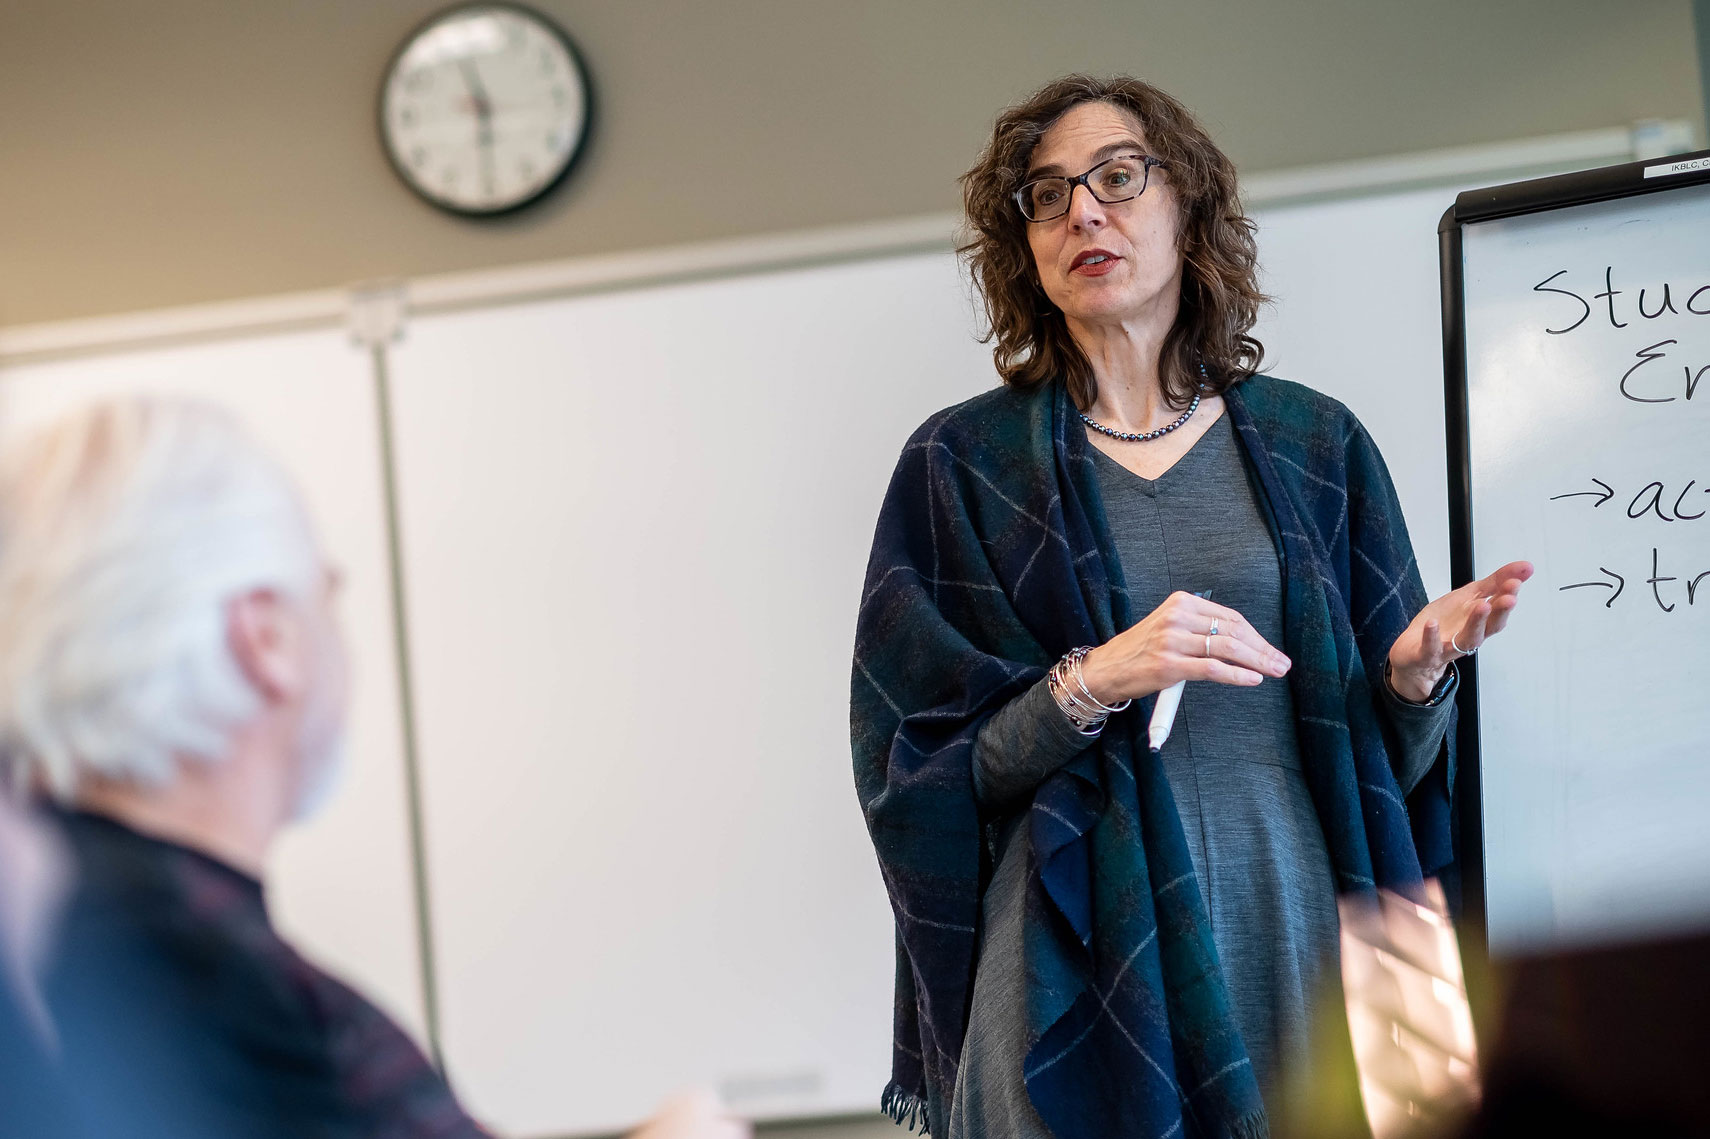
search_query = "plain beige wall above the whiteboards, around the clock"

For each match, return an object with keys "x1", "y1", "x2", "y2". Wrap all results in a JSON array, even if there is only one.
[{"x1": 0, "y1": 0, "x2": 1700, "y2": 325}]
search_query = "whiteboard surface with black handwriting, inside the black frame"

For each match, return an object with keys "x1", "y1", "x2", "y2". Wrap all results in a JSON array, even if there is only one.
[{"x1": 1462, "y1": 177, "x2": 1710, "y2": 953}]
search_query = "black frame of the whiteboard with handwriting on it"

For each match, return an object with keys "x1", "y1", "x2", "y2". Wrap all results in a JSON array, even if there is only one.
[{"x1": 1436, "y1": 150, "x2": 1710, "y2": 985}]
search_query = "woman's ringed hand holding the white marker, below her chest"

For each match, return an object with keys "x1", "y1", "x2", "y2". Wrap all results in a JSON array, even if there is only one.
[{"x1": 1081, "y1": 592, "x2": 1293, "y2": 705}]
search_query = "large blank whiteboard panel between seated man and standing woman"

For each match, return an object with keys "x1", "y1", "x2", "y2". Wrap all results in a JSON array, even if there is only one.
[{"x1": 390, "y1": 253, "x2": 994, "y2": 1136}]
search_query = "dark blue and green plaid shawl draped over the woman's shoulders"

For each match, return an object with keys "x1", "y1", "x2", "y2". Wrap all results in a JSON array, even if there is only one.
[{"x1": 850, "y1": 376, "x2": 1454, "y2": 1139}]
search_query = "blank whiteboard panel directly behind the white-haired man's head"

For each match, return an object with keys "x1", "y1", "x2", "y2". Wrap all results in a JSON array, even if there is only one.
[{"x1": 0, "y1": 332, "x2": 424, "y2": 1040}]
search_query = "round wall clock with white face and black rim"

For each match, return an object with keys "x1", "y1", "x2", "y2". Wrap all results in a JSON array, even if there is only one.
[{"x1": 380, "y1": 3, "x2": 588, "y2": 214}]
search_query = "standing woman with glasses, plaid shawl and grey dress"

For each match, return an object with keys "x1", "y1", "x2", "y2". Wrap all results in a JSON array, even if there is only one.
[{"x1": 852, "y1": 77, "x2": 1532, "y2": 1139}]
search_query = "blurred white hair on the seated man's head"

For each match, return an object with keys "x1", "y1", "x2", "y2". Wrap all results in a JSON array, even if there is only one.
[{"x1": 0, "y1": 397, "x2": 323, "y2": 799}]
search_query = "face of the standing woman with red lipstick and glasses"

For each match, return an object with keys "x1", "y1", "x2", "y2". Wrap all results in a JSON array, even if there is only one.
[{"x1": 1026, "y1": 103, "x2": 1182, "y2": 327}]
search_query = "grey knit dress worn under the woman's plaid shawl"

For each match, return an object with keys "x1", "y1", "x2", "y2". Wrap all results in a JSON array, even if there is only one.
[{"x1": 949, "y1": 416, "x2": 1452, "y2": 1139}]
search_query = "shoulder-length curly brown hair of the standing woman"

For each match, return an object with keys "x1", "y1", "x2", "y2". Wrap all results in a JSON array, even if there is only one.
[{"x1": 958, "y1": 75, "x2": 1271, "y2": 409}]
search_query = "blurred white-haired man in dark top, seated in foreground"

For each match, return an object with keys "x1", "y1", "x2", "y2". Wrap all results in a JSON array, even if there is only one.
[{"x1": 0, "y1": 400, "x2": 747, "y2": 1139}]
